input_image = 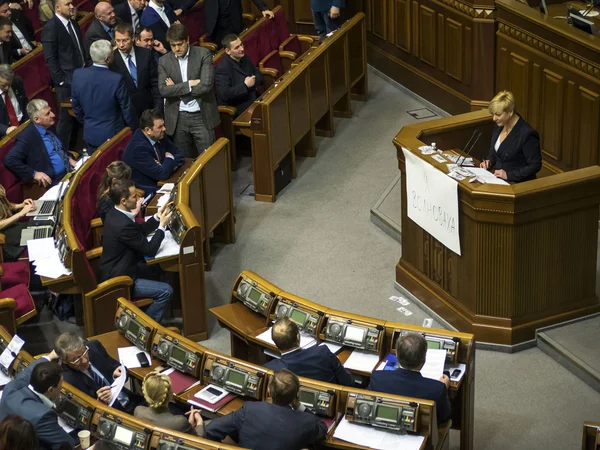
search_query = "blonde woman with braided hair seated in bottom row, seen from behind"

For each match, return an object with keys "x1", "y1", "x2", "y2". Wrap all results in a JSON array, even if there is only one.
[{"x1": 133, "y1": 372, "x2": 204, "y2": 437}]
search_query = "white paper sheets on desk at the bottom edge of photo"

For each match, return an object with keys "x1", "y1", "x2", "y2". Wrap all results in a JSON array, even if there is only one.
[{"x1": 333, "y1": 417, "x2": 425, "y2": 450}]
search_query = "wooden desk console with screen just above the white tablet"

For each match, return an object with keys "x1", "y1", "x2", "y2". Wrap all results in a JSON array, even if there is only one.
[{"x1": 203, "y1": 354, "x2": 267, "y2": 400}]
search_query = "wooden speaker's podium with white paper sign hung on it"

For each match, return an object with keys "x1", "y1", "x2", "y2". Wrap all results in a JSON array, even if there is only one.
[{"x1": 394, "y1": 111, "x2": 600, "y2": 350}]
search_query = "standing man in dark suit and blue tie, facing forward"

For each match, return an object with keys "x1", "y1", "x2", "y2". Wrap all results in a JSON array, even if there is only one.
[{"x1": 108, "y1": 23, "x2": 164, "y2": 118}]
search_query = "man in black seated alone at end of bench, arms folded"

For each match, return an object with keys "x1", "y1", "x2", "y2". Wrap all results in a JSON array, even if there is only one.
[{"x1": 215, "y1": 34, "x2": 263, "y2": 117}]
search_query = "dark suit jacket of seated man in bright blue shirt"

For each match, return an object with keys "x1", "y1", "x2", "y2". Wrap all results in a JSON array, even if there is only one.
[{"x1": 4, "y1": 123, "x2": 64, "y2": 181}]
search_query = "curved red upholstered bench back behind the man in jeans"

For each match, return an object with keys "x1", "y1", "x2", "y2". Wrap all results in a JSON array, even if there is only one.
[{"x1": 71, "y1": 131, "x2": 131, "y2": 250}]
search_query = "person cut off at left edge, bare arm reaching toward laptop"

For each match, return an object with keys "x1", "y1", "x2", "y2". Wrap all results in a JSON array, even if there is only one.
[{"x1": 0, "y1": 185, "x2": 35, "y2": 261}]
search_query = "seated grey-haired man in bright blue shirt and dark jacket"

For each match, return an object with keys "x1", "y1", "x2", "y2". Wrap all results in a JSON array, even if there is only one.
[{"x1": 4, "y1": 99, "x2": 77, "y2": 187}]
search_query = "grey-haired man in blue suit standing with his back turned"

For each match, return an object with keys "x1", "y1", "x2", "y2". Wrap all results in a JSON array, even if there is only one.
[{"x1": 72, "y1": 40, "x2": 138, "y2": 151}]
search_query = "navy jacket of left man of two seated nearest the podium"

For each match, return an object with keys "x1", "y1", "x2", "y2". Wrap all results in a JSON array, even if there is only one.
[{"x1": 265, "y1": 345, "x2": 354, "y2": 386}]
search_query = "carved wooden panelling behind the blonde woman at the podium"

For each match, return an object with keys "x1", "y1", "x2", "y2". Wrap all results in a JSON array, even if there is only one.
[{"x1": 496, "y1": 21, "x2": 600, "y2": 172}]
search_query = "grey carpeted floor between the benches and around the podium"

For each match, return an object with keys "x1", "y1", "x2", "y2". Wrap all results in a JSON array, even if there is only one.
[{"x1": 202, "y1": 67, "x2": 600, "y2": 449}]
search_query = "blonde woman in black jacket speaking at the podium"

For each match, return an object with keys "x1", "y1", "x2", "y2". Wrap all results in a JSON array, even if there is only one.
[{"x1": 480, "y1": 91, "x2": 542, "y2": 183}]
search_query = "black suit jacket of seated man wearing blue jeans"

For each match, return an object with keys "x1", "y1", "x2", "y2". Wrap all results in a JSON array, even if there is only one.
[{"x1": 100, "y1": 208, "x2": 165, "y2": 281}]
